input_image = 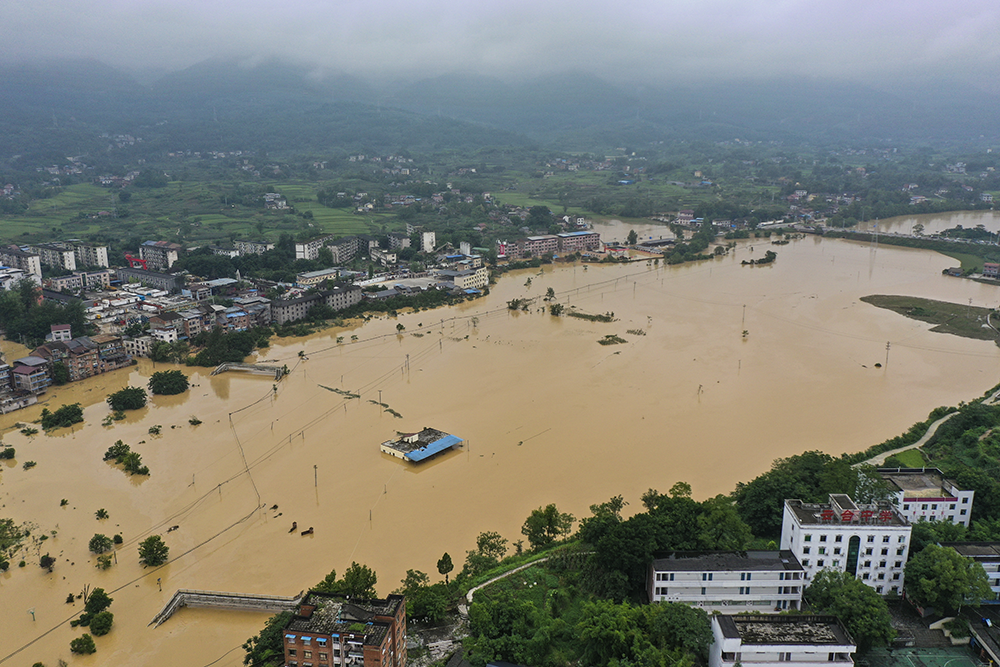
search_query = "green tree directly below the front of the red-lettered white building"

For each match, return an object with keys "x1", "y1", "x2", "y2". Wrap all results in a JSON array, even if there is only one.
[{"x1": 805, "y1": 569, "x2": 909, "y2": 653}]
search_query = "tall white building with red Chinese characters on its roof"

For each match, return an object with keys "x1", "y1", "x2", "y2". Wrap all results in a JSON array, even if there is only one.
[{"x1": 781, "y1": 494, "x2": 911, "y2": 595}]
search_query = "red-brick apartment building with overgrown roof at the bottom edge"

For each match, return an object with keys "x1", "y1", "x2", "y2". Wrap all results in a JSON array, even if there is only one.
[{"x1": 282, "y1": 591, "x2": 406, "y2": 667}]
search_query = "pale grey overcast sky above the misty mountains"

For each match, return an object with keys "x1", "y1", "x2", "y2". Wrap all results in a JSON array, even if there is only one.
[{"x1": 0, "y1": 0, "x2": 1000, "y2": 85}]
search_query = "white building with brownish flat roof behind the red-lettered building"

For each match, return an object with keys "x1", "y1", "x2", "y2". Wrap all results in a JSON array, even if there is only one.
[{"x1": 878, "y1": 468, "x2": 976, "y2": 528}]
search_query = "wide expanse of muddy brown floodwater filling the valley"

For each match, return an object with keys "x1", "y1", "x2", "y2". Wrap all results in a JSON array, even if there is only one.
[{"x1": 0, "y1": 218, "x2": 1000, "y2": 667}]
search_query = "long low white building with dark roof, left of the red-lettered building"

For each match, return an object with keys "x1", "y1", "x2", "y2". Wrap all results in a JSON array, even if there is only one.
[{"x1": 646, "y1": 551, "x2": 805, "y2": 613}]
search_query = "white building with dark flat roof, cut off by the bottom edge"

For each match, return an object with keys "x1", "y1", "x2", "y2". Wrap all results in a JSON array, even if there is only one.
[{"x1": 708, "y1": 614, "x2": 858, "y2": 667}]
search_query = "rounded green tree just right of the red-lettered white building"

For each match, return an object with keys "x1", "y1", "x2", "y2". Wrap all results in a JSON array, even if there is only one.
[{"x1": 905, "y1": 544, "x2": 993, "y2": 616}]
